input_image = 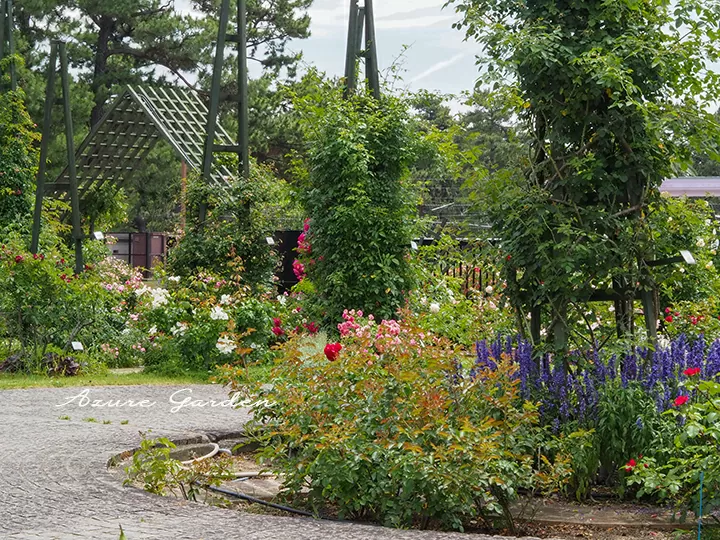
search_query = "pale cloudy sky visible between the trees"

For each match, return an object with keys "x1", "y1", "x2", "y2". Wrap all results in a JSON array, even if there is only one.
[{"x1": 175, "y1": 0, "x2": 479, "y2": 98}]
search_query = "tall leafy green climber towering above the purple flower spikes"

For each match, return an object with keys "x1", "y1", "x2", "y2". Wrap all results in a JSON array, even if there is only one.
[{"x1": 448, "y1": 0, "x2": 720, "y2": 349}]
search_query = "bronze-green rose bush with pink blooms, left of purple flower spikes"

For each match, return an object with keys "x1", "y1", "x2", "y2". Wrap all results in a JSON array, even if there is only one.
[{"x1": 246, "y1": 311, "x2": 570, "y2": 529}]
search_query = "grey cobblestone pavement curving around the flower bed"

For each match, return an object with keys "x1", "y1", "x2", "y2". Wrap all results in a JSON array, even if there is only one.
[{"x1": 0, "y1": 385, "x2": 548, "y2": 540}]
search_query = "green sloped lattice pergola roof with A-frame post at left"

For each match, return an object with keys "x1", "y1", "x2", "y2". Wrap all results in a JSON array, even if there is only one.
[{"x1": 31, "y1": 85, "x2": 233, "y2": 273}]
